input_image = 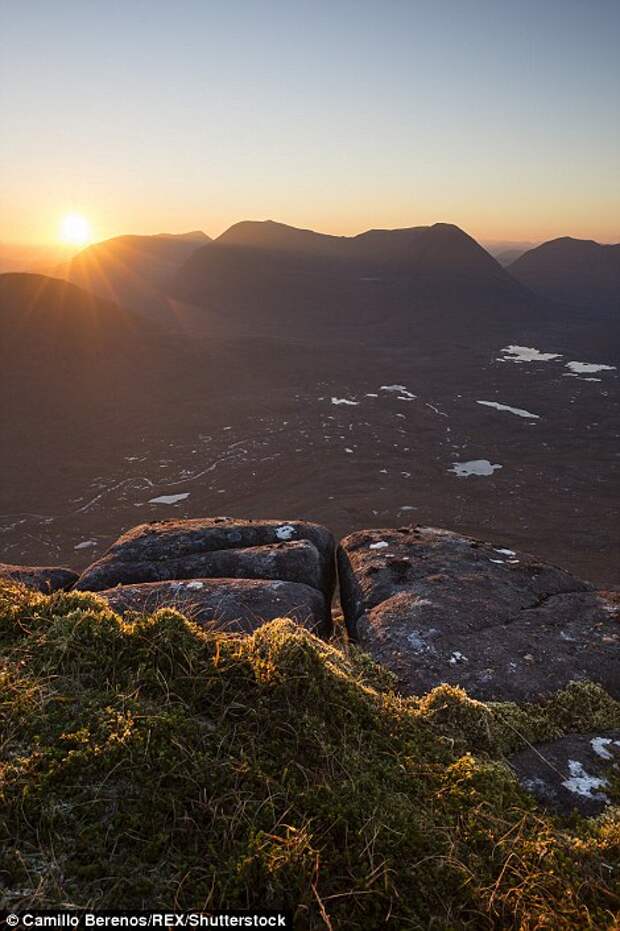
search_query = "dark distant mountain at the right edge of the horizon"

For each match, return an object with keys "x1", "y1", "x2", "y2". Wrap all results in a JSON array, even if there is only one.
[{"x1": 509, "y1": 236, "x2": 620, "y2": 308}]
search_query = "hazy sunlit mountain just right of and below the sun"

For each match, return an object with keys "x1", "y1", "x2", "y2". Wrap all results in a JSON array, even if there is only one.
[{"x1": 56, "y1": 231, "x2": 210, "y2": 315}]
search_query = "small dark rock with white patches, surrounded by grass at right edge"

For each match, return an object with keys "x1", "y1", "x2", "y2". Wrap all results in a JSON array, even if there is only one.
[{"x1": 509, "y1": 731, "x2": 620, "y2": 816}]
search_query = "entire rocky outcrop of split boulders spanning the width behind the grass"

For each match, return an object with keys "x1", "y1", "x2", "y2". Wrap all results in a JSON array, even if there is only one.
[{"x1": 0, "y1": 517, "x2": 620, "y2": 701}]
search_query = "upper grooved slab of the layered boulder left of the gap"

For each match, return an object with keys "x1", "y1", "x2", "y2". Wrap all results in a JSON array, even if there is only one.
[{"x1": 76, "y1": 517, "x2": 335, "y2": 600}]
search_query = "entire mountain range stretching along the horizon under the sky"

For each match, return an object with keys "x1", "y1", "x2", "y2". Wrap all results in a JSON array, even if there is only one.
[{"x1": 0, "y1": 220, "x2": 620, "y2": 315}]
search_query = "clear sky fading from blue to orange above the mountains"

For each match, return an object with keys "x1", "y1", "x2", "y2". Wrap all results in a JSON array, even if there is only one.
[{"x1": 0, "y1": 0, "x2": 620, "y2": 242}]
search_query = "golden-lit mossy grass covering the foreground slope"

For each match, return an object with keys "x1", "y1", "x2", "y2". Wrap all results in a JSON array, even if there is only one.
[{"x1": 0, "y1": 585, "x2": 620, "y2": 931}]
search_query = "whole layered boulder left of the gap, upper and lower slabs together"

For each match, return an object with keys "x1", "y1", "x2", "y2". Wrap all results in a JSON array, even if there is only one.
[{"x1": 76, "y1": 517, "x2": 335, "y2": 635}]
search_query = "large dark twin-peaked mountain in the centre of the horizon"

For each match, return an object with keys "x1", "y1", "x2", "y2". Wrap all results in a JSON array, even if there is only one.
[{"x1": 171, "y1": 220, "x2": 525, "y2": 341}]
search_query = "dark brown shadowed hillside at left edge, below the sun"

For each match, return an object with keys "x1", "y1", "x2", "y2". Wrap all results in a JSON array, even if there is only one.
[{"x1": 0, "y1": 274, "x2": 189, "y2": 494}]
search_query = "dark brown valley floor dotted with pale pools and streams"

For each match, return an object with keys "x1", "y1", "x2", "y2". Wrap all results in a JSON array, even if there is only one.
[{"x1": 0, "y1": 340, "x2": 620, "y2": 588}]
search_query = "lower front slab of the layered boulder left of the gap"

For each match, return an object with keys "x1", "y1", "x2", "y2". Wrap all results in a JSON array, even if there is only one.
[{"x1": 98, "y1": 579, "x2": 331, "y2": 636}]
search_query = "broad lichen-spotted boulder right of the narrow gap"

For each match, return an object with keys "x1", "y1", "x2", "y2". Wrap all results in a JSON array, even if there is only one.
[{"x1": 338, "y1": 527, "x2": 620, "y2": 701}]
